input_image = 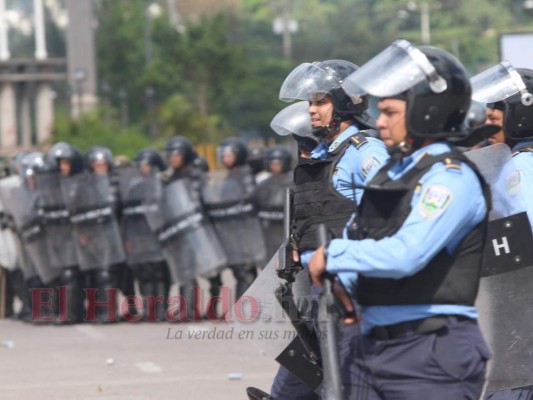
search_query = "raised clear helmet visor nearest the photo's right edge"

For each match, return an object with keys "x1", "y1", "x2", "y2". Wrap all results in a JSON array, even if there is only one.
[{"x1": 470, "y1": 61, "x2": 533, "y2": 105}]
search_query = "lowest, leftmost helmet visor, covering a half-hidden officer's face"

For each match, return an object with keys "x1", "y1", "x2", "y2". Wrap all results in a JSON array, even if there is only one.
[{"x1": 270, "y1": 101, "x2": 313, "y2": 137}]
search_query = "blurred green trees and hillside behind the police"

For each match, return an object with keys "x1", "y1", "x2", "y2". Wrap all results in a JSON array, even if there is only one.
[{"x1": 17, "y1": 0, "x2": 533, "y2": 149}]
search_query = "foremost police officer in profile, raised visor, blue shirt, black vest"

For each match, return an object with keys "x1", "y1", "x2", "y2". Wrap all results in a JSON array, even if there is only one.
[{"x1": 310, "y1": 40, "x2": 490, "y2": 400}]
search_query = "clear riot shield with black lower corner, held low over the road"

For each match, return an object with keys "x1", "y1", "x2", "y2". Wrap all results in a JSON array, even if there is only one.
[{"x1": 226, "y1": 253, "x2": 322, "y2": 392}]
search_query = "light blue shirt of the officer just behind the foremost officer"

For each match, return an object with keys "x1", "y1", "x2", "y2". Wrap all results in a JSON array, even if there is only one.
[{"x1": 300, "y1": 125, "x2": 389, "y2": 270}]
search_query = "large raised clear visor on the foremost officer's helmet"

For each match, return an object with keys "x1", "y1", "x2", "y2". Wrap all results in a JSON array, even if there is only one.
[{"x1": 342, "y1": 40, "x2": 446, "y2": 98}]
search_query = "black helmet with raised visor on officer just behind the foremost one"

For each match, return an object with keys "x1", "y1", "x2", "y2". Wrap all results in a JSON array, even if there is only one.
[{"x1": 279, "y1": 60, "x2": 374, "y2": 137}]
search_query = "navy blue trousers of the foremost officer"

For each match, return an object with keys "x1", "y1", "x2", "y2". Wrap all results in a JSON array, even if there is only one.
[{"x1": 340, "y1": 317, "x2": 490, "y2": 400}]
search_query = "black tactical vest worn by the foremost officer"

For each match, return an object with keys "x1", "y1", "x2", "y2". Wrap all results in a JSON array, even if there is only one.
[{"x1": 357, "y1": 151, "x2": 491, "y2": 306}]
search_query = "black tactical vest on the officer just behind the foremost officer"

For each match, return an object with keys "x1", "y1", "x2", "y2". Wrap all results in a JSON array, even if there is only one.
[{"x1": 292, "y1": 132, "x2": 368, "y2": 252}]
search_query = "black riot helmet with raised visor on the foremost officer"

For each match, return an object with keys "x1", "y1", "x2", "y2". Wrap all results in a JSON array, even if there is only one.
[{"x1": 343, "y1": 40, "x2": 472, "y2": 145}]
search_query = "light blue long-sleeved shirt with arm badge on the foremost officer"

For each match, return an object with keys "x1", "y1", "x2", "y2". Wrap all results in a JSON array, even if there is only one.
[{"x1": 327, "y1": 143, "x2": 487, "y2": 332}]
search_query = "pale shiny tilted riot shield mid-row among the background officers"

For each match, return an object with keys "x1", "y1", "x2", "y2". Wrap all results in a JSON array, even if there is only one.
[{"x1": 146, "y1": 178, "x2": 227, "y2": 283}]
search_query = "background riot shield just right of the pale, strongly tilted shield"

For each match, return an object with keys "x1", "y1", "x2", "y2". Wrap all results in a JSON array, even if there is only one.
[{"x1": 202, "y1": 167, "x2": 266, "y2": 265}]
